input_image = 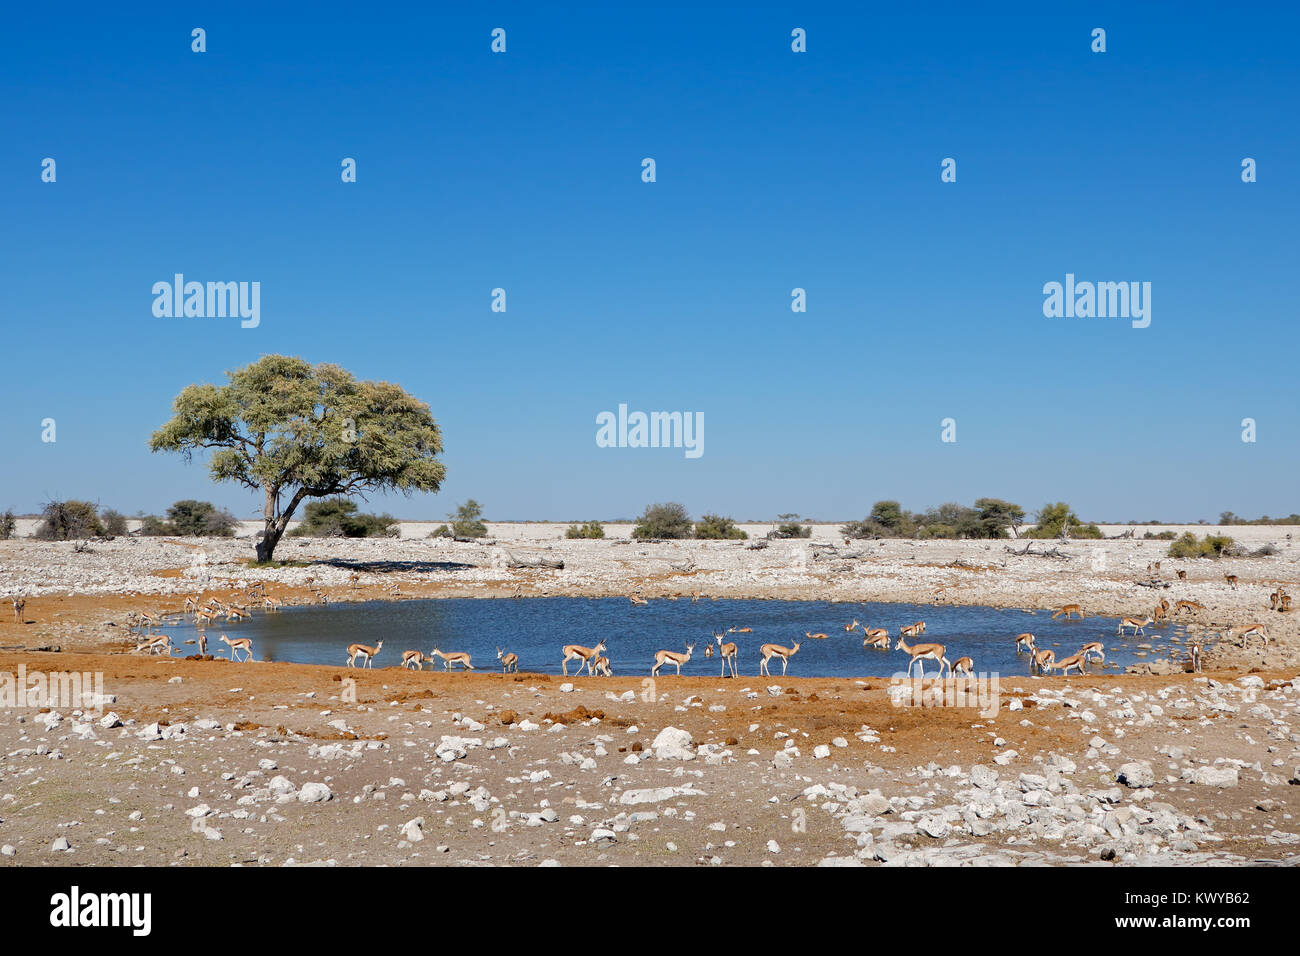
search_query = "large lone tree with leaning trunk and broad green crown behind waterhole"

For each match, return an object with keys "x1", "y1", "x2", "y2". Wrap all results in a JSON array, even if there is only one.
[{"x1": 150, "y1": 355, "x2": 446, "y2": 561}]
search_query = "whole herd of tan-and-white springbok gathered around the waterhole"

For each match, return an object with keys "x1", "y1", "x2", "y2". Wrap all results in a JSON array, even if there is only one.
[{"x1": 10, "y1": 575, "x2": 1291, "y2": 679}]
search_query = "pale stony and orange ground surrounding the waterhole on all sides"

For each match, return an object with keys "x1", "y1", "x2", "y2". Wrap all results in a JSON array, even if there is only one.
[{"x1": 0, "y1": 528, "x2": 1300, "y2": 865}]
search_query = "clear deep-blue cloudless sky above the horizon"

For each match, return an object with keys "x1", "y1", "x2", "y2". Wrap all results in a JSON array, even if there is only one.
[{"x1": 0, "y1": 4, "x2": 1300, "y2": 520}]
